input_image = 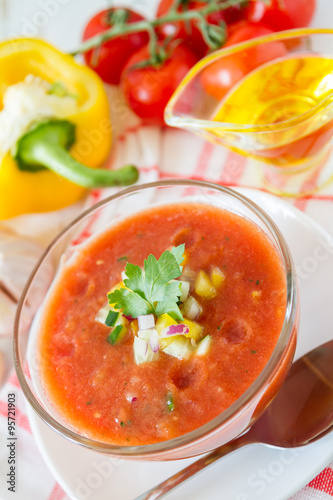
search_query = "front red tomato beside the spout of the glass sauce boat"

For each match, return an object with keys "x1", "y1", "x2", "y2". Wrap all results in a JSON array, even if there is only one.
[{"x1": 120, "y1": 44, "x2": 198, "y2": 125}]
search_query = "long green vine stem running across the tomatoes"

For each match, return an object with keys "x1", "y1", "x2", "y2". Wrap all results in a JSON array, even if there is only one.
[{"x1": 71, "y1": 0, "x2": 248, "y2": 56}]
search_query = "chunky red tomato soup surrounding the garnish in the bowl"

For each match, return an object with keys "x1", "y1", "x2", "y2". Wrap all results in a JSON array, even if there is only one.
[{"x1": 39, "y1": 203, "x2": 286, "y2": 445}]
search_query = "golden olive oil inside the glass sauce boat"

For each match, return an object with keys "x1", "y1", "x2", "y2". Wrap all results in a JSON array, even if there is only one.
[{"x1": 213, "y1": 53, "x2": 333, "y2": 168}]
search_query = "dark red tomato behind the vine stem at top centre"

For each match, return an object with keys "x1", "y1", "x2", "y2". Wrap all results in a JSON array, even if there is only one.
[{"x1": 156, "y1": 0, "x2": 243, "y2": 57}]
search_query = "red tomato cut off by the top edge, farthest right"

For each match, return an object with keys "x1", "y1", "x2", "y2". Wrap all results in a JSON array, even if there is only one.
[{"x1": 245, "y1": 0, "x2": 316, "y2": 31}]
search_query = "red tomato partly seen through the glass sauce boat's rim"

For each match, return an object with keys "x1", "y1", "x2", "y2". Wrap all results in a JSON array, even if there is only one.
[{"x1": 201, "y1": 21, "x2": 287, "y2": 99}]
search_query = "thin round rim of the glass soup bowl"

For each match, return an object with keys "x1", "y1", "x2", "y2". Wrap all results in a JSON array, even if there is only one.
[{"x1": 13, "y1": 179, "x2": 298, "y2": 458}]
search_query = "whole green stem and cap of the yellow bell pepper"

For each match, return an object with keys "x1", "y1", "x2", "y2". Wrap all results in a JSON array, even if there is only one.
[{"x1": 14, "y1": 120, "x2": 138, "y2": 188}]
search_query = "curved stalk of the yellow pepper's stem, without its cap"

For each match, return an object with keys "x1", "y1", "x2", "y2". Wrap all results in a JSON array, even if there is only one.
[{"x1": 30, "y1": 142, "x2": 138, "y2": 188}]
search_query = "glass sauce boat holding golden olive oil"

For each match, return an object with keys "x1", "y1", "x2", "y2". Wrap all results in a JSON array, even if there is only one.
[{"x1": 165, "y1": 28, "x2": 333, "y2": 196}]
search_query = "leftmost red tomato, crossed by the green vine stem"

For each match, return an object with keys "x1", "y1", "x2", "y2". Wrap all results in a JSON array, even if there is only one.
[{"x1": 83, "y1": 8, "x2": 149, "y2": 85}]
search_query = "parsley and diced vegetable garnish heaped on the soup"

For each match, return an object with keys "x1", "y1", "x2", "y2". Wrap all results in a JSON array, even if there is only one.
[{"x1": 106, "y1": 245, "x2": 214, "y2": 364}]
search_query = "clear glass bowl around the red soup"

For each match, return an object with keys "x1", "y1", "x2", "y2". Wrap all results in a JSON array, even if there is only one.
[{"x1": 14, "y1": 180, "x2": 299, "y2": 460}]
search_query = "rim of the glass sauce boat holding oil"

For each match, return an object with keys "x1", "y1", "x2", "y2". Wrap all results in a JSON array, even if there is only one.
[{"x1": 164, "y1": 28, "x2": 333, "y2": 134}]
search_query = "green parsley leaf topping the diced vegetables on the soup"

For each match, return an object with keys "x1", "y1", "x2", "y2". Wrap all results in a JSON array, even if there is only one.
[{"x1": 108, "y1": 244, "x2": 185, "y2": 321}]
